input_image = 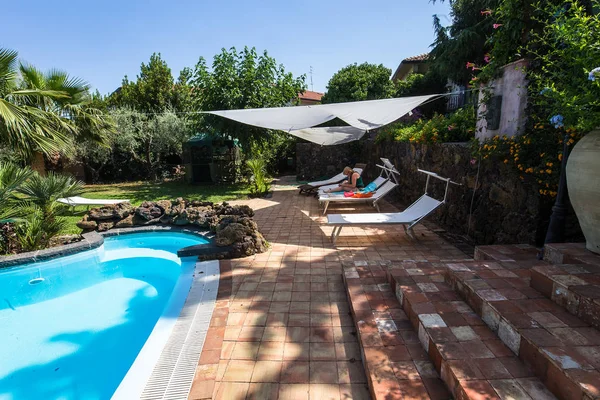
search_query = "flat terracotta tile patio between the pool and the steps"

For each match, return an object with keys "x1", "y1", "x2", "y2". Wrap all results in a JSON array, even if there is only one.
[{"x1": 189, "y1": 182, "x2": 468, "y2": 400}]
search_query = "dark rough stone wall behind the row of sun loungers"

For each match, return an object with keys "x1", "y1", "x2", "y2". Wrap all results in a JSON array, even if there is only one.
[{"x1": 297, "y1": 141, "x2": 580, "y2": 245}]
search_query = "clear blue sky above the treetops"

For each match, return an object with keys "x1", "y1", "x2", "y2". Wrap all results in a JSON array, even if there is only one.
[{"x1": 0, "y1": 0, "x2": 448, "y2": 94}]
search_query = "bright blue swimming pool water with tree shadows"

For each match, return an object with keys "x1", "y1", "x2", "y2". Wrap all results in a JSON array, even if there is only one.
[{"x1": 0, "y1": 233, "x2": 206, "y2": 400}]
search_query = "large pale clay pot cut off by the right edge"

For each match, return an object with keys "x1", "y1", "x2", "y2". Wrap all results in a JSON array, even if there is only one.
[{"x1": 567, "y1": 130, "x2": 600, "y2": 253}]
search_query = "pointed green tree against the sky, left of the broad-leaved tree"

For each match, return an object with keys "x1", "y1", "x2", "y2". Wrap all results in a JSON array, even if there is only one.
[{"x1": 109, "y1": 53, "x2": 190, "y2": 113}]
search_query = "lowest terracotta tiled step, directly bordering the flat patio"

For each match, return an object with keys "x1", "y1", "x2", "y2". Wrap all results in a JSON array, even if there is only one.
[{"x1": 344, "y1": 262, "x2": 450, "y2": 400}]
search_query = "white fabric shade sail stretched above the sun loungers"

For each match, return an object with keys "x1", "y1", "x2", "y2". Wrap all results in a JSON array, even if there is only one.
[{"x1": 205, "y1": 94, "x2": 441, "y2": 145}]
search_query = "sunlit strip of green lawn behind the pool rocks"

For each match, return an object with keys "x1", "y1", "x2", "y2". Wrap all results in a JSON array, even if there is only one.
[{"x1": 63, "y1": 182, "x2": 249, "y2": 234}]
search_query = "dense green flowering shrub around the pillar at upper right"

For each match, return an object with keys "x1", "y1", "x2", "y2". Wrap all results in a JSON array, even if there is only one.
[{"x1": 470, "y1": 0, "x2": 600, "y2": 197}]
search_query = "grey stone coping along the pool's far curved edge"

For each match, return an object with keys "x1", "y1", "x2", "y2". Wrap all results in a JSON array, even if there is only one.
[{"x1": 0, "y1": 225, "x2": 223, "y2": 269}]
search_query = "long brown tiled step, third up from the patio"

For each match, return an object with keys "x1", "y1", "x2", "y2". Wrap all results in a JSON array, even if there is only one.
[{"x1": 442, "y1": 261, "x2": 600, "y2": 399}]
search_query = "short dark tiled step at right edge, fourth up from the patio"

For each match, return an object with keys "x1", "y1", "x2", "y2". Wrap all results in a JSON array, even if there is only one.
[{"x1": 531, "y1": 264, "x2": 600, "y2": 328}]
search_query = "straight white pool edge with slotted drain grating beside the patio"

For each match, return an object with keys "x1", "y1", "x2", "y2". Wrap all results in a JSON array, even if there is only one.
[{"x1": 112, "y1": 261, "x2": 219, "y2": 400}]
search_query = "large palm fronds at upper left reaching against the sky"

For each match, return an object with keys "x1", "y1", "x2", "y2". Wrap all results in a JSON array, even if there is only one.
[{"x1": 0, "y1": 48, "x2": 115, "y2": 156}]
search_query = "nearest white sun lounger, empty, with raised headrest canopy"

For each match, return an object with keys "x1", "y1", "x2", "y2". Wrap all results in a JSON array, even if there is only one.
[{"x1": 327, "y1": 169, "x2": 460, "y2": 244}]
